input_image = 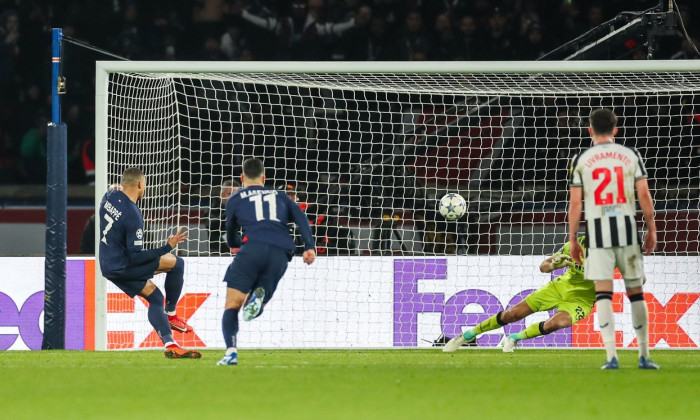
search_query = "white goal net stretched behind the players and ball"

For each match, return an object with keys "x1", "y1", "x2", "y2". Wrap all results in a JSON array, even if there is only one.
[{"x1": 96, "y1": 62, "x2": 700, "y2": 349}]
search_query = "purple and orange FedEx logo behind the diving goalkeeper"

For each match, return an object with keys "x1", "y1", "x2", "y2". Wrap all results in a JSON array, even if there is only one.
[{"x1": 393, "y1": 259, "x2": 700, "y2": 347}]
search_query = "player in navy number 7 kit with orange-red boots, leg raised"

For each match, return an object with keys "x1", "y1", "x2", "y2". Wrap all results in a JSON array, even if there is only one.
[{"x1": 99, "y1": 168, "x2": 202, "y2": 359}]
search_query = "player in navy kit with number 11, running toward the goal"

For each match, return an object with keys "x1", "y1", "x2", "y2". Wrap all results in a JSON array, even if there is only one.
[{"x1": 217, "y1": 158, "x2": 316, "y2": 365}]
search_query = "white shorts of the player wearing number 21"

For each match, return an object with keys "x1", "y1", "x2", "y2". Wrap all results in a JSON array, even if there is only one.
[{"x1": 583, "y1": 245, "x2": 644, "y2": 288}]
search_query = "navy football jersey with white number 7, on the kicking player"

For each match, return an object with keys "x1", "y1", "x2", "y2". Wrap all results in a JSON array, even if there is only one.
[{"x1": 99, "y1": 190, "x2": 172, "y2": 278}]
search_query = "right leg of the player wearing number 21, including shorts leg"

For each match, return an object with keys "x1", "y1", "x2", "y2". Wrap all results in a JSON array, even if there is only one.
[{"x1": 618, "y1": 246, "x2": 659, "y2": 370}]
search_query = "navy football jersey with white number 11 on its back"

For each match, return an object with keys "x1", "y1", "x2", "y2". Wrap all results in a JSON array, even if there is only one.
[{"x1": 226, "y1": 186, "x2": 315, "y2": 255}]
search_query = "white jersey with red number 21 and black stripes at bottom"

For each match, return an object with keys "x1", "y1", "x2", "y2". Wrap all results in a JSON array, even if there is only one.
[{"x1": 570, "y1": 143, "x2": 647, "y2": 248}]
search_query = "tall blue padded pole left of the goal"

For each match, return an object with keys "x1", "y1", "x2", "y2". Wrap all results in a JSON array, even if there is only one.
[{"x1": 41, "y1": 28, "x2": 68, "y2": 350}]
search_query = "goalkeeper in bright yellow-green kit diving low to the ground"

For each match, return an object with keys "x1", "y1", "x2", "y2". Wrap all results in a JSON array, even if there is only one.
[{"x1": 442, "y1": 236, "x2": 595, "y2": 353}]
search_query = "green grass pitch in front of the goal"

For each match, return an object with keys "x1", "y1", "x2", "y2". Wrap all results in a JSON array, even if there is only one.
[{"x1": 0, "y1": 349, "x2": 700, "y2": 420}]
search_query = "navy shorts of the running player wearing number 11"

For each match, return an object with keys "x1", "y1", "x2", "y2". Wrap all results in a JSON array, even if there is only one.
[{"x1": 224, "y1": 243, "x2": 290, "y2": 303}]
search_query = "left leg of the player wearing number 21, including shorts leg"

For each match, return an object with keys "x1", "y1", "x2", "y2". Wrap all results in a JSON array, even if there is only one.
[{"x1": 583, "y1": 248, "x2": 618, "y2": 369}]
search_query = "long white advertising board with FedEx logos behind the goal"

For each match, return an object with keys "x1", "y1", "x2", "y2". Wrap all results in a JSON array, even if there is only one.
[{"x1": 0, "y1": 256, "x2": 700, "y2": 350}]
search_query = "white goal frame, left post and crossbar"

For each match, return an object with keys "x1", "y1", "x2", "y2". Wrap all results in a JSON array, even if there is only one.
[{"x1": 95, "y1": 60, "x2": 700, "y2": 350}]
